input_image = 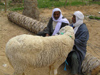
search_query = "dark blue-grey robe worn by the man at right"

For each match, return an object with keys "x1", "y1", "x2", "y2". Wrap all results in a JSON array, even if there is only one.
[{"x1": 67, "y1": 23, "x2": 89, "y2": 73}]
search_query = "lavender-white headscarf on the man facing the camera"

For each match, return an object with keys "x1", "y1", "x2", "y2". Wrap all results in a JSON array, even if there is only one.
[{"x1": 52, "y1": 8, "x2": 69, "y2": 35}]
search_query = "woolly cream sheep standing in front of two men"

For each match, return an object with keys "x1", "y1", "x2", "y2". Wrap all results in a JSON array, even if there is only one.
[{"x1": 5, "y1": 26, "x2": 75, "y2": 75}]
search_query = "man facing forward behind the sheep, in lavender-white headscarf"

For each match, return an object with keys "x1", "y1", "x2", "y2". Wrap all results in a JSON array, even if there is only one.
[{"x1": 37, "y1": 8, "x2": 69, "y2": 36}]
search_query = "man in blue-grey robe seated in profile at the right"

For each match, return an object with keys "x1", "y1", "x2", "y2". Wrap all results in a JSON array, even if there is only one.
[{"x1": 67, "y1": 11, "x2": 89, "y2": 75}]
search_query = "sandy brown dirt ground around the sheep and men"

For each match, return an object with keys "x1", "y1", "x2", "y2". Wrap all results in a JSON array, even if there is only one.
[{"x1": 0, "y1": 5, "x2": 100, "y2": 75}]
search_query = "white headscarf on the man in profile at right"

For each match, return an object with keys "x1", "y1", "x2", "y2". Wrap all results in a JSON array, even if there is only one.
[{"x1": 73, "y1": 11, "x2": 84, "y2": 33}]
